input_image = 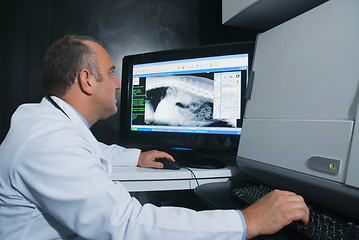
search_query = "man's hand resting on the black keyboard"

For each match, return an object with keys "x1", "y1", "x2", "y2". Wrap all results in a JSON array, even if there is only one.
[{"x1": 242, "y1": 190, "x2": 309, "y2": 239}]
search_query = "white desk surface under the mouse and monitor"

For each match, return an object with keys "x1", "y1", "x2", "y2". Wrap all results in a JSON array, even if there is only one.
[{"x1": 111, "y1": 166, "x2": 236, "y2": 192}]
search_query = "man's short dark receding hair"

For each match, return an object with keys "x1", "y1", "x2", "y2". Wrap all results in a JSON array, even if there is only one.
[{"x1": 42, "y1": 35, "x2": 102, "y2": 96}]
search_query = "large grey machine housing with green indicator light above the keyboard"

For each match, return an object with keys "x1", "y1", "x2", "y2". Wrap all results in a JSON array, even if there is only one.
[{"x1": 237, "y1": 0, "x2": 359, "y2": 221}]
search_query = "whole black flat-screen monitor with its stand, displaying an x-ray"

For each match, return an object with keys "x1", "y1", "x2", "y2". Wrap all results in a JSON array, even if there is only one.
[{"x1": 120, "y1": 43, "x2": 254, "y2": 168}]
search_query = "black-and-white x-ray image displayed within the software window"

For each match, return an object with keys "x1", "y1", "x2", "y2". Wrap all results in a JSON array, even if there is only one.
[{"x1": 145, "y1": 73, "x2": 236, "y2": 127}]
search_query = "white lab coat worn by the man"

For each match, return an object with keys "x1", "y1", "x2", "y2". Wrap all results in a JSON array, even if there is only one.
[{"x1": 0, "y1": 97, "x2": 246, "y2": 240}]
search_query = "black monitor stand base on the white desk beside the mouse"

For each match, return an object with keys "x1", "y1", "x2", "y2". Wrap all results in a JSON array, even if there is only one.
[{"x1": 167, "y1": 149, "x2": 225, "y2": 169}]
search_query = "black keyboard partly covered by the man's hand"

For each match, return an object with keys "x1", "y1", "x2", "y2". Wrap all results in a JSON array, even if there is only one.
[{"x1": 232, "y1": 183, "x2": 359, "y2": 240}]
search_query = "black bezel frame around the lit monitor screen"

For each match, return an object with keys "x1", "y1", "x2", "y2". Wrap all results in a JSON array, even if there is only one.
[{"x1": 119, "y1": 42, "x2": 255, "y2": 154}]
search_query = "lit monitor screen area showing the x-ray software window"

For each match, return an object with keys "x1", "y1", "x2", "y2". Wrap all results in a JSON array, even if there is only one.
[{"x1": 131, "y1": 54, "x2": 248, "y2": 134}]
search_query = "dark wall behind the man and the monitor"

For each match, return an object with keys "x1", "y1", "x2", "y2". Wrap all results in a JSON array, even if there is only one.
[{"x1": 0, "y1": 0, "x2": 258, "y2": 143}]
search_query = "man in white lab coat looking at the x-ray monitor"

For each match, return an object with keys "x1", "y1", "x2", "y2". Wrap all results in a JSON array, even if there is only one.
[{"x1": 0, "y1": 36, "x2": 309, "y2": 240}]
